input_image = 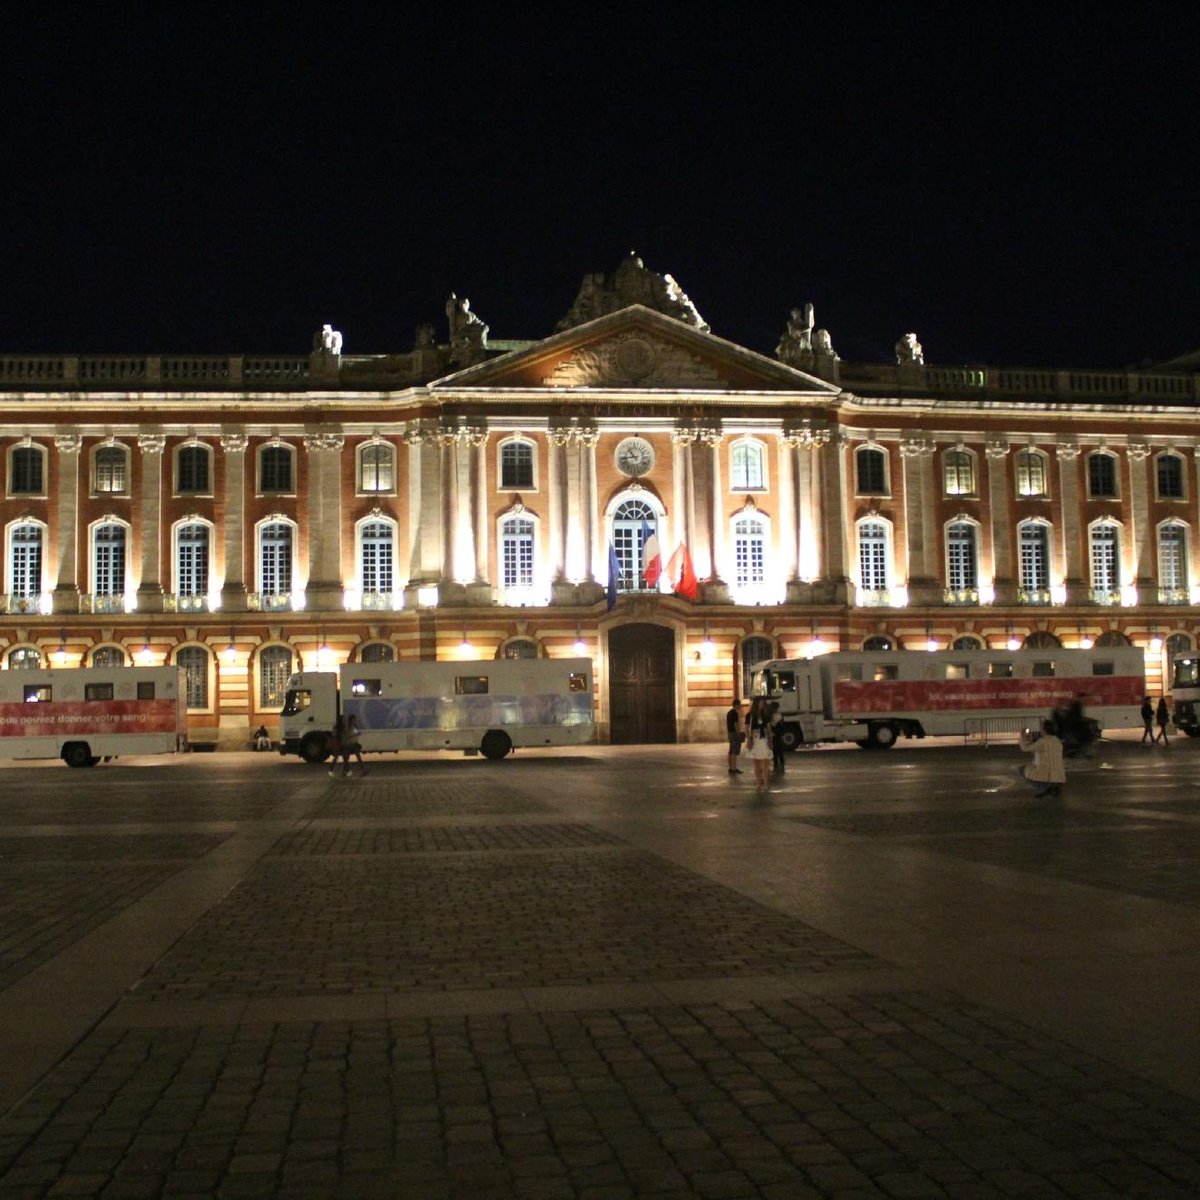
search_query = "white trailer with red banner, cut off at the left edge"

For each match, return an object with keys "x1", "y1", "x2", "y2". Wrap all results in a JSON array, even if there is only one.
[{"x1": 0, "y1": 667, "x2": 187, "y2": 767}]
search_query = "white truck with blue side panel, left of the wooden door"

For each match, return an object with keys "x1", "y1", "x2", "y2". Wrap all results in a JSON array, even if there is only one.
[{"x1": 280, "y1": 659, "x2": 595, "y2": 762}]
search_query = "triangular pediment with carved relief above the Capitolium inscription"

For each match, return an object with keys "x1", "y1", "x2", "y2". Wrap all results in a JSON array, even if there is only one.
[{"x1": 430, "y1": 305, "x2": 840, "y2": 395}]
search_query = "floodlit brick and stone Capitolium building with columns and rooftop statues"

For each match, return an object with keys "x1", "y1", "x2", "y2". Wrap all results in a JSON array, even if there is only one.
[{"x1": 0, "y1": 257, "x2": 1200, "y2": 748}]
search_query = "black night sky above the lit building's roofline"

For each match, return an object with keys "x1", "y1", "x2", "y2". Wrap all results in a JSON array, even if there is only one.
[{"x1": 0, "y1": 4, "x2": 1200, "y2": 367}]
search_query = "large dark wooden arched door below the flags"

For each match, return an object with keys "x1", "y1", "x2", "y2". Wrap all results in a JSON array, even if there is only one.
[{"x1": 608, "y1": 625, "x2": 676, "y2": 745}]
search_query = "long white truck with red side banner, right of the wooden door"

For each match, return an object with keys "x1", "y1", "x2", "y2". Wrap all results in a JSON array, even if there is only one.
[{"x1": 751, "y1": 646, "x2": 1146, "y2": 750}]
